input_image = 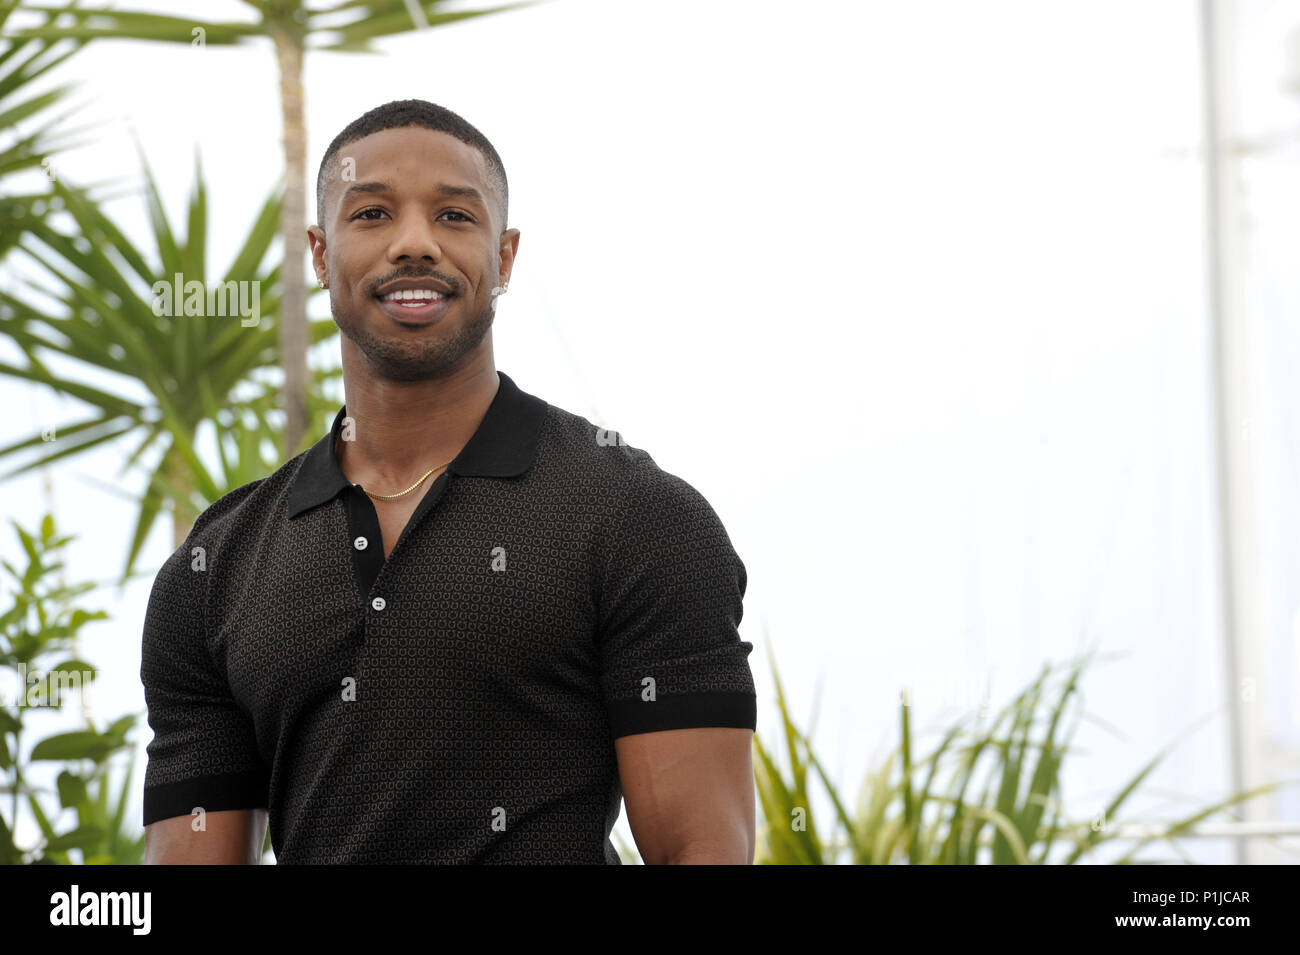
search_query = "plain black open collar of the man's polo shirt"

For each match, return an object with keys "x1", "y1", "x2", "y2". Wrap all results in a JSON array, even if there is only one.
[{"x1": 289, "y1": 372, "x2": 546, "y2": 518}]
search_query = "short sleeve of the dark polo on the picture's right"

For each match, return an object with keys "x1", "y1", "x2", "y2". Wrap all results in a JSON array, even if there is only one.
[{"x1": 598, "y1": 462, "x2": 757, "y2": 738}]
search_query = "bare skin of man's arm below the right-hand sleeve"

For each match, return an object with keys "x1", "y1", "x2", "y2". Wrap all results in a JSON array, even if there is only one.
[{"x1": 614, "y1": 726, "x2": 754, "y2": 865}]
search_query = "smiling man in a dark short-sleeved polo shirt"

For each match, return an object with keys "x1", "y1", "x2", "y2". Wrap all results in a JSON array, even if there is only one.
[{"x1": 140, "y1": 100, "x2": 757, "y2": 864}]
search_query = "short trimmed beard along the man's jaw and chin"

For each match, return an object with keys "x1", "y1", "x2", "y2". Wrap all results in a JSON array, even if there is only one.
[{"x1": 330, "y1": 296, "x2": 497, "y2": 381}]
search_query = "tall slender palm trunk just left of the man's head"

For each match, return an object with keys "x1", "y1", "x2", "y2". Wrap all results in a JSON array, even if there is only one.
[{"x1": 273, "y1": 29, "x2": 307, "y2": 460}]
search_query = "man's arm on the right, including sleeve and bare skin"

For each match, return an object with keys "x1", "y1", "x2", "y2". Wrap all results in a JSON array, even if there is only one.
[{"x1": 597, "y1": 459, "x2": 757, "y2": 865}]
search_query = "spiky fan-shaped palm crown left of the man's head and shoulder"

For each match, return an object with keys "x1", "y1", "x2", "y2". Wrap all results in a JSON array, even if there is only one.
[{"x1": 0, "y1": 155, "x2": 337, "y2": 581}]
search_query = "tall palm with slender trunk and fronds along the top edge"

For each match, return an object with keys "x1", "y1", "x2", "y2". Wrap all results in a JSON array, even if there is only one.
[{"x1": 0, "y1": 0, "x2": 537, "y2": 448}]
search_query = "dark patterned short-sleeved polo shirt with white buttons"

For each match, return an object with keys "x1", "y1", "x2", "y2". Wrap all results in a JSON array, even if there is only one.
[{"x1": 140, "y1": 372, "x2": 755, "y2": 864}]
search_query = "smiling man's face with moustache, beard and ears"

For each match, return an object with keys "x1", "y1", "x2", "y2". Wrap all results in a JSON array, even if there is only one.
[{"x1": 308, "y1": 126, "x2": 519, "y2": 381}]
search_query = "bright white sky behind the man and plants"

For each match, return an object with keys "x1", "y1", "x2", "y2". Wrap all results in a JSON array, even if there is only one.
[{"x1": 0, "y1": 0, "x2": 1300, "y2": 861}]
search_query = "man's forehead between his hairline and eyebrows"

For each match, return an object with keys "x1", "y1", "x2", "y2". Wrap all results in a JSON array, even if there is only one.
[{"x1": 329, "y1": 126, "x2": 499, "y2": 209}]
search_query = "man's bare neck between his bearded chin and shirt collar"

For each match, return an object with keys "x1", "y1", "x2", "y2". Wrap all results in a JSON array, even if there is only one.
[{"x1": 334, "y1": 359, "x2": 499, "y2": 494}]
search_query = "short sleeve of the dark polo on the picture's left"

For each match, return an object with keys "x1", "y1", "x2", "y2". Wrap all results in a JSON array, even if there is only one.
[{"x1": 140, "y1": 533, "x2": 268, "y2": 825}]
